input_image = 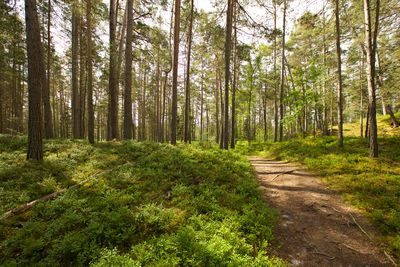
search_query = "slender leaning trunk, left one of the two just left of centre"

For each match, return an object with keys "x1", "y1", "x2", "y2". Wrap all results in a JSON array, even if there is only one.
[{"x1": 171, "y1": 0, "x2": 181, "y2": 145}]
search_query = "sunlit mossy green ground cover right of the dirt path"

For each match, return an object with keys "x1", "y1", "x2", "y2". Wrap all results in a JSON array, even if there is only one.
[{"x1": 238, "y1": 116, "x2": 400, "y2": 260}]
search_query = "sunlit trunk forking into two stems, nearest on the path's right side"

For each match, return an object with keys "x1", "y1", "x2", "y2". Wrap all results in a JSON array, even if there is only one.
[{"x1": 364, "y1": 0, "x2": 380, "y2": 157}]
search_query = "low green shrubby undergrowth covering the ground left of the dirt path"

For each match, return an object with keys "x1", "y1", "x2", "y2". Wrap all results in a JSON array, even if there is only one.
[{"x1": 0, "y1": 136, "x2": 286, "y2": 266}]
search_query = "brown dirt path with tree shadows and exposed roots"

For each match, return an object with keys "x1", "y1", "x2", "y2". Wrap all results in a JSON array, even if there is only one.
[{"x1": 248, "y1": 157, "x2": 394, "y2": 267}]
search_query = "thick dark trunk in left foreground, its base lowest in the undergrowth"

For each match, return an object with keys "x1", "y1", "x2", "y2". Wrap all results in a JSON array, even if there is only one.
[{"x1": 25, "y1": 0, "x2": 44, "y2": 160}]
